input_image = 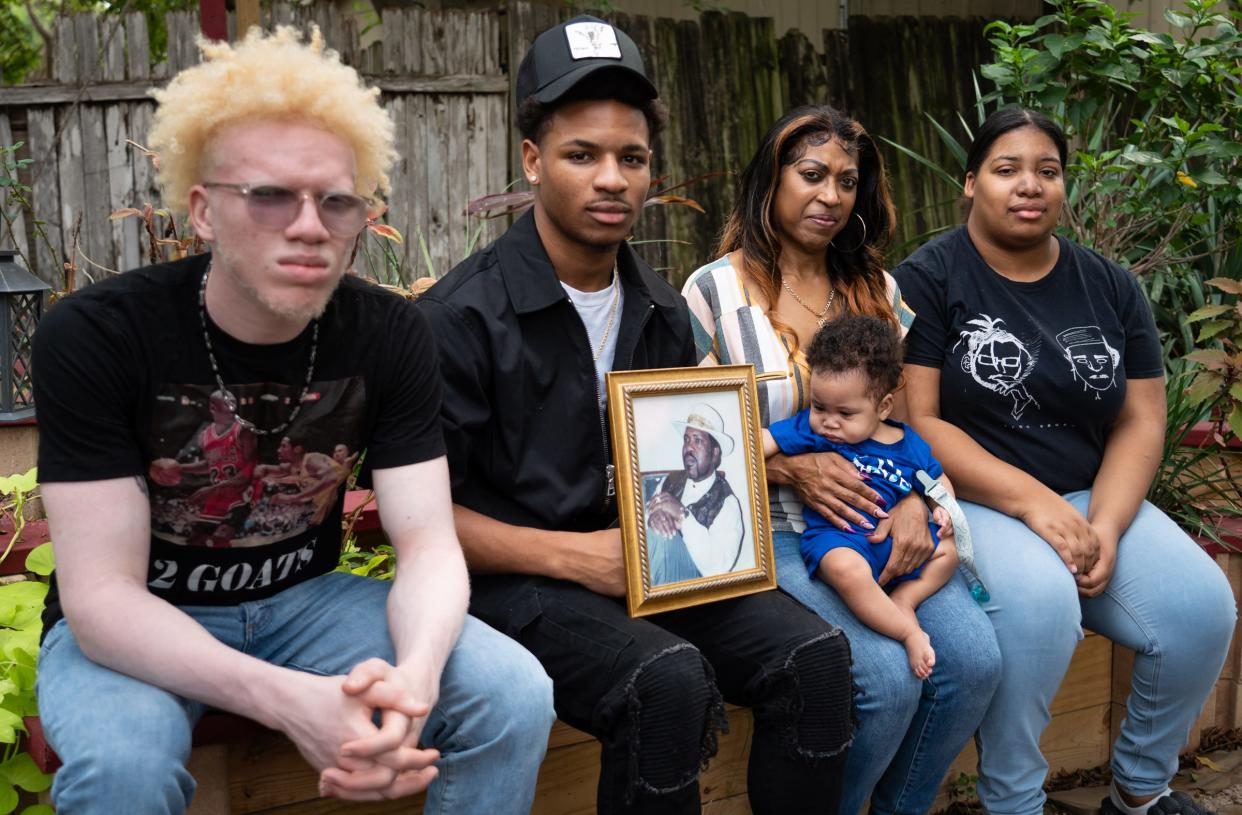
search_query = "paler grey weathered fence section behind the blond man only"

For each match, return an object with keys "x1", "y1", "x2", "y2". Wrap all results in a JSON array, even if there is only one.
[{"x1": 0, "y1": 4, "x2": 509, "y2": 285}]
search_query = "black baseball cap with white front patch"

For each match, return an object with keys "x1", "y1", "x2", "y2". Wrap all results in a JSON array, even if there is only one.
[{"x1": 517, "y1": 14, "x2": 660, "y2": 107}]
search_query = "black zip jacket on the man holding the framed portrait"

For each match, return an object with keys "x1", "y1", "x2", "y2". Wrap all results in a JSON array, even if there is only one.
[{"x1": 417, "y1": 212, "x2": 696, "y2": 532}]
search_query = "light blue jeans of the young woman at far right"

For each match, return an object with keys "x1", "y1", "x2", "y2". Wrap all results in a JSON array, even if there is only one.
[{"x1": 963, "y1": 489, "x2": 1236, "y2": 815}]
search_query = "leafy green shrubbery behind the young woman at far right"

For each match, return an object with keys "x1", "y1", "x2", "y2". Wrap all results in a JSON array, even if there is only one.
[{"x1": 980, "y1": 0, "x2": 1242, "y2": 452}]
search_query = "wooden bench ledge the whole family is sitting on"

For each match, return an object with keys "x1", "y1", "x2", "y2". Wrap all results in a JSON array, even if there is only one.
[{"x1": 19, "y1": 506, "x2": 1242, "y2": 815}]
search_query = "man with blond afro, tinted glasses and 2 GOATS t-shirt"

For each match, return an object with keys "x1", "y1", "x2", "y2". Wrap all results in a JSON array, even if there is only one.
[{"x1": 35, "y1": 29, "x2": 553, "y2": 815}]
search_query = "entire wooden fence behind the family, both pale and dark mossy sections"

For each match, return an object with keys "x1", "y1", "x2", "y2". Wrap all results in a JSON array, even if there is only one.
[{"x1": 0, "y1": 2, "x2": 1008, "y2": 286}]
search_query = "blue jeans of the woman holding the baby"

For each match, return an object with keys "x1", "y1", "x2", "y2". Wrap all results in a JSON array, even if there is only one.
[{"x1": 774, "y1": 532, "x2": 1001, "y2": 815}]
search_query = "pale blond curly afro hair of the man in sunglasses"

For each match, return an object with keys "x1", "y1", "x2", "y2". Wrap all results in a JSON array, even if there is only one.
[{"x1": 149, "y1": 26, "x2": 396, "y2": 212}]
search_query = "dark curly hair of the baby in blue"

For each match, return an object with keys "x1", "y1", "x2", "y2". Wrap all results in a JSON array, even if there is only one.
[{"x1": 806, "y1": 314, "x2": 904, "y2": 400}]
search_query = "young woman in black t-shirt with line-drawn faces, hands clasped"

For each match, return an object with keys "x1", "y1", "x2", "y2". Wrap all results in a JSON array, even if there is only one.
[{"x1": 894, "y1": 108, "x2": 1235, "y2": 815}]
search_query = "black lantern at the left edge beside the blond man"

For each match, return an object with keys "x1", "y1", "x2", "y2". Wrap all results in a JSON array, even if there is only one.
[{"x1": 0, "y1": 248, "x2": 52, "y2": 422}]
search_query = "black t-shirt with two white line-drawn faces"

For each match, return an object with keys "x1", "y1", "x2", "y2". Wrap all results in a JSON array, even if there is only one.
[{"x1": 893, "y1": 226, "x2": 1164, "y2": 493}]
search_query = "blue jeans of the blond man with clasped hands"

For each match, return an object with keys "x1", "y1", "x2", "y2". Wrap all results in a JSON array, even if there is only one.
[{"x1": 39, "y1": 573, "x2": 554, "y2": 815}]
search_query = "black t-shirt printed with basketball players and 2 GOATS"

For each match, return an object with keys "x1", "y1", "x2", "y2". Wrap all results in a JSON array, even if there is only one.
[{"x1": 32, "y1": 256, "x2": 445, "y2": 630}]
